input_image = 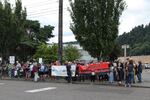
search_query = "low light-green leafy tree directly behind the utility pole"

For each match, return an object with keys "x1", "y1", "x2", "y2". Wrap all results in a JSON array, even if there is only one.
[{"x1": 34, "y1": 43, "x2": 80, "y2": 62}]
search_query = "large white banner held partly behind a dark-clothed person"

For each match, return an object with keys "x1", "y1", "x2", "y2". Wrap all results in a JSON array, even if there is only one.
[{"x1": 52, "y1": 65, "x2": 76, "y2": 76}]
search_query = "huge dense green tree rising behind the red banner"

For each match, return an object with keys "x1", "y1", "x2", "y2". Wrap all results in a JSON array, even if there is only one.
[{"x1": 69, "y1": 0, "x2": 125, "y2": 60}]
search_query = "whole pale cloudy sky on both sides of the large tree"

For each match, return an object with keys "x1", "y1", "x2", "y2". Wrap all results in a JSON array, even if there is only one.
[{"x1": 10, "y1": 0, "x2": 150, "y2": 43}]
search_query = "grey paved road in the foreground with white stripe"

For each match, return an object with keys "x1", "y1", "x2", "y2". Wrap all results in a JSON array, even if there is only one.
[{"x1": 0, "y1": 80, "x2": 150, "y2": 100}]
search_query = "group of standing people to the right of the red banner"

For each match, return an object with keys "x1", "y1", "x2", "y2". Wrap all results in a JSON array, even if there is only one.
[{"x1": 109, "y1": 59, "x2": 143, "y2": 87}]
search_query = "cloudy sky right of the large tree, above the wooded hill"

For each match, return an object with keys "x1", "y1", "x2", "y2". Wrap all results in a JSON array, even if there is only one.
[{"x1": 119, "y1": 0, "x2": 150, "y2": 34}]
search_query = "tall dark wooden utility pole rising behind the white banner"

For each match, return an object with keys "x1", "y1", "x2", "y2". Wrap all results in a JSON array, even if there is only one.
[{"x1": 58, "y1": 0, "x2": 63, "y2": 64}]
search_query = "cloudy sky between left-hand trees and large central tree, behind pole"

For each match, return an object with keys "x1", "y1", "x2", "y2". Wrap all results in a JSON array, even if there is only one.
[{"x1": 22, "y1": 0, "x2": 75, "y2": 43}]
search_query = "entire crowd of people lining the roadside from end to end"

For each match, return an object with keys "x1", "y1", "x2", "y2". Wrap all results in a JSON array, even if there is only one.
[{"x1": 0, "y1": 59, "x2": 142, "y2": 87}]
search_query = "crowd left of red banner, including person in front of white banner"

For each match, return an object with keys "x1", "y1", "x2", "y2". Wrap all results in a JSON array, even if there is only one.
[{"x1": 0, "y1": 61, "x2": 75, "y2": 83}]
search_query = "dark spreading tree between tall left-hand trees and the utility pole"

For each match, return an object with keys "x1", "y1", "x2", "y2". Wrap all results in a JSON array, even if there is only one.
[{"x1": 18, "y1": 20, "x2": 54, "y2": 59}]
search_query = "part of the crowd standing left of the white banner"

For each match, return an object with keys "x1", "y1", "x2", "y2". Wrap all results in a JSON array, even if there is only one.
[{"x1": 0, "y1": 61, "x2": 58, "y2": 81}]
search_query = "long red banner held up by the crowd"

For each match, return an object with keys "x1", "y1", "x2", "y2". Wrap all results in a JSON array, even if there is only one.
[{"x1": 79, "y1": 62, "x2": 109, "y2": 74}]
